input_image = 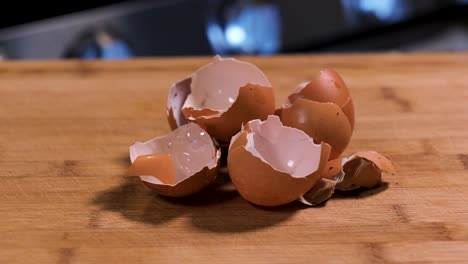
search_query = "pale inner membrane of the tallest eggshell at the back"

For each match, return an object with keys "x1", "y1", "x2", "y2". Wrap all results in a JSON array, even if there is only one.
[{"x1": 182, "y1": 56, "x2": 271, "y2": 117}]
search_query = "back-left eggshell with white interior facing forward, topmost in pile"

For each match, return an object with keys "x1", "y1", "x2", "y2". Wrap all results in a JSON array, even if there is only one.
[{"x1": 167, "y1": 56, "x2": 275, "y2": 143}]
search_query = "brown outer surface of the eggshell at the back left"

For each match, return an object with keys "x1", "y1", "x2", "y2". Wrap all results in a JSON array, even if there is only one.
[{"x1": 182, "y1": 83, "x2": 275, "y2": 142}]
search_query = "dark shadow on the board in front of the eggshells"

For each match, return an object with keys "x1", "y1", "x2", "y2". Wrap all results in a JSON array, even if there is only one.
[{"x1": 92, "y1": 175, "x2": 308, "y2": 232}]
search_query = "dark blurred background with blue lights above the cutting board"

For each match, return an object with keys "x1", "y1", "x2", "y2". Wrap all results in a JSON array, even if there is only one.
[{"x1": 0, "y1": 0, "x2": 468, "y2": 59}]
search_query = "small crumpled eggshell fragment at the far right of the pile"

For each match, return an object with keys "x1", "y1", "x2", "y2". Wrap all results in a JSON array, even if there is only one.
[{"x1": 336, "y1": 151, "x2": 395, "y2": 191}]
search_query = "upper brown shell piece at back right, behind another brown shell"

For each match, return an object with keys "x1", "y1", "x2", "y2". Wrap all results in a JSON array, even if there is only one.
[{"x1": 283, "y1": 69, "x2": 355, "y2": 131}]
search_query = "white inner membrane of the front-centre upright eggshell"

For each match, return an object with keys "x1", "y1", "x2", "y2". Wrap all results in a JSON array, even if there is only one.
[{"x1": 241, "y1": 115, "x2": 322, "y2": 178}]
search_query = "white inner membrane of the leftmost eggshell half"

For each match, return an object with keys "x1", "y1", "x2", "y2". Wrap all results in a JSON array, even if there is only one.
[{"x1": 130, "y1": 123, "x2": 221, "y2": 185}]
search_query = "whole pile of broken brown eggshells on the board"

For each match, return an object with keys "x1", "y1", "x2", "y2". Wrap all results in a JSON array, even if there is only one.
[{"x1": 129, "y1": 56, "x2": 394, "y2": 206}]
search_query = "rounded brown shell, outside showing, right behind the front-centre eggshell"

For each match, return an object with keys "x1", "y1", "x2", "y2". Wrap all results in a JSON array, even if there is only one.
[{"x1": 276, "y1": 99, "x2": 352, "y2": 159}]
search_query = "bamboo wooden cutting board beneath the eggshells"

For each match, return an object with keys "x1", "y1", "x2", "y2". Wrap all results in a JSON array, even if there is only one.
[{"x1": 0, "y1": 53, "x2": 468, "y2": 264}]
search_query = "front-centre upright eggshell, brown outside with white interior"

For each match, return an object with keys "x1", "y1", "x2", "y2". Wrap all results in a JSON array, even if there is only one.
[{"x1": 228, "y1": 115, "x2": 330, "y2": 206}]
